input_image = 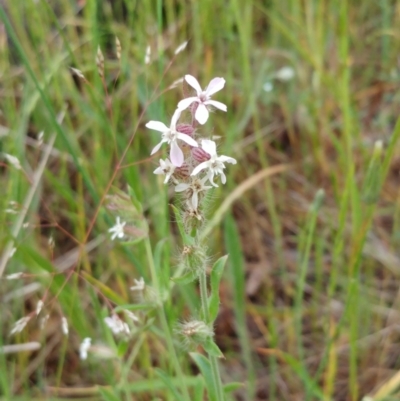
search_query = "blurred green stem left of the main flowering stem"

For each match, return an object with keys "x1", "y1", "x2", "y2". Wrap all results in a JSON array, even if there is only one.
[{"x1": 145, "y1": 237, "x2": 191, "y2": 401}]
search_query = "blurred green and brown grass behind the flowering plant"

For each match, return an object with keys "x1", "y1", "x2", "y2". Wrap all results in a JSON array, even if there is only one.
[{"x1": 0, "y1": 0, "x2": 400, "y2": 401}]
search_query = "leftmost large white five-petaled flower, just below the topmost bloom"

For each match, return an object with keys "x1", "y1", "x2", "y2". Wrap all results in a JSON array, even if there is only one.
[{"x1": 146, "y1": 109, "x2": 199, "y2": 167}]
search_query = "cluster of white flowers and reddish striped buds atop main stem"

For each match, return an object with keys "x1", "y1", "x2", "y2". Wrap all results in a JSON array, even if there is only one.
[{"x1": 146, "y1": 75, "x2": 236, "y2": 220}]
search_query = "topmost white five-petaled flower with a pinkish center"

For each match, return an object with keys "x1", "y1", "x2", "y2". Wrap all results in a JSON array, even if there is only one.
[{"x1": 178, "y1": 75, "x2": 227, "y2": 124}]
